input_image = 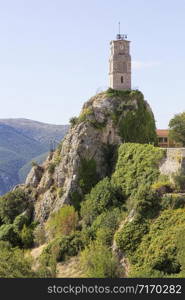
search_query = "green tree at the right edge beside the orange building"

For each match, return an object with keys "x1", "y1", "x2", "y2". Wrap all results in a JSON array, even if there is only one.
[{"x1": 169, "y1": 112, "x2": 185, "y2": 146}]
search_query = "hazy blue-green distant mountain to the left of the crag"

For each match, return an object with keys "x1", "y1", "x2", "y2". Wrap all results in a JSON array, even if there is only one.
[{"x1": 0, "y1": 119, "x2": 68, "y2": 194}]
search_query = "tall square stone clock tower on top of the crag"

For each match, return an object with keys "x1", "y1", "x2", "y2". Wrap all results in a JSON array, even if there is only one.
[{"x1": 109, "y1": 34, "x2": 131, "y2": 90}]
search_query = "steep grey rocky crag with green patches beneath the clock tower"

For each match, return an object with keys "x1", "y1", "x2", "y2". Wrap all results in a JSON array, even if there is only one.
[{"x1": 22, "y1": 89, "x2": 156, "y2": 222}]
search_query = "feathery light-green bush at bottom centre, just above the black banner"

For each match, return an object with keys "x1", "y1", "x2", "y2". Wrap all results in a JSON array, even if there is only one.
[{"x1": 80, "y1": 242, "x2": 119, "y2": 278}]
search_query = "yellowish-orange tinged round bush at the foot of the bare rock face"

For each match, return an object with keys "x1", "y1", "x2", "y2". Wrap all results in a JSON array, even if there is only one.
[{"x1": 46, "y1": 205, "x2": 78, "y2": 237}]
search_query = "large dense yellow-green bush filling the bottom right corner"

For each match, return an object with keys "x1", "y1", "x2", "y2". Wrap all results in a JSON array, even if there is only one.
[{"x1": 131, "y1": 209, "x2": 185, "y2": 277}]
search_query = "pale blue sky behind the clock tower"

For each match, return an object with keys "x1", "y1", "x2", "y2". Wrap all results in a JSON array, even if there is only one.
[{"x1": 0, "y1": 0, "x2": 185, "y2": 128}]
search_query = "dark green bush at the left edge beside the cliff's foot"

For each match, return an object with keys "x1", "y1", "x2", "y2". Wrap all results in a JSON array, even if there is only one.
[{"x1": 0, "y1": 189, "x2": 28, "y2": 224}]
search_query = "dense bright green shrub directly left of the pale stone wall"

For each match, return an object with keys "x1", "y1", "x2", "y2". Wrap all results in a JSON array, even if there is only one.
[{"x1": 112, "y1": 143, "x2": 165, "y2": 197}]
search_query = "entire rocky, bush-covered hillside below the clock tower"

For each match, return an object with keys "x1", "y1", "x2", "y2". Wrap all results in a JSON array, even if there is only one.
[{"x1": 0, "y1": 89, "x2": 185, "y2": 278}]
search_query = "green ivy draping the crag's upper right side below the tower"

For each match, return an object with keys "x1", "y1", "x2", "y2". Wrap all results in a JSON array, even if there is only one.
[{"x1": 107, "y1": 88, "x2": 157, "y2": 144}]
